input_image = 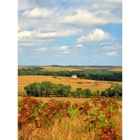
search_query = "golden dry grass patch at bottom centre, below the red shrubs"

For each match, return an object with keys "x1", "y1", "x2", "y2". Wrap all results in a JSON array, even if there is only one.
[{"x1": 21, "y1": 117, "x2": 95, "y2": 140}]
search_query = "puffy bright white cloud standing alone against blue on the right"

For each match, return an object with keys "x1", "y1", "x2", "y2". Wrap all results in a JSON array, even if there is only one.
[{"x1": 77, "y1": 28, "x2": 113, "y2": 43}]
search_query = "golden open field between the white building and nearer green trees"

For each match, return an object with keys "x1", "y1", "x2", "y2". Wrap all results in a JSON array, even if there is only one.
[{"x1": 18, "y1": 76, "x2": 122, "y2": 95}]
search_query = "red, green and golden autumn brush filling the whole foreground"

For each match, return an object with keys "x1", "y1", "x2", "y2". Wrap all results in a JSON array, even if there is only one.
[{"x1": 18, "y1": 97, "x2": 122, "y2": 140}]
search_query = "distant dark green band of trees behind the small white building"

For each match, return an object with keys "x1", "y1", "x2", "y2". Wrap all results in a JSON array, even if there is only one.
[{"x1": 18, "y1": 69, "x2": 122, "y2": 81}]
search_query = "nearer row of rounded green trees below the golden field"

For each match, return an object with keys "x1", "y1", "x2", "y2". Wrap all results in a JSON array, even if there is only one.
[{"x1": 24, "y1": 81, "x2": 122, "y2": 98}]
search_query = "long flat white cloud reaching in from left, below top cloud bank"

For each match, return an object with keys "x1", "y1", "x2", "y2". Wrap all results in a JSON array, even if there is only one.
[{"x1": 18, "y1": 28, "x2": 80, "y2": 46}]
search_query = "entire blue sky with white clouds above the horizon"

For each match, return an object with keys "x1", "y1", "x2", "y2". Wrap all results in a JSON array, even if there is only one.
[{"x1": 18, "y1": 0, "x2": 122, "y2": 66}]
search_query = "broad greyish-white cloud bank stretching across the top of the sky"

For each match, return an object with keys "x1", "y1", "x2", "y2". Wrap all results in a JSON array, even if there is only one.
[{"x1": 19, "y1": 0, "x2": 121, "y2": 28}]
